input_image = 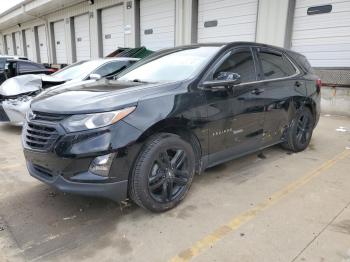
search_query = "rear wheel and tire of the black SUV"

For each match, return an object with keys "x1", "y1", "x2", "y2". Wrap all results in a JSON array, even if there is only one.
[{"x1": 281, "y1": 107, "x2": 315, "y2": 152}]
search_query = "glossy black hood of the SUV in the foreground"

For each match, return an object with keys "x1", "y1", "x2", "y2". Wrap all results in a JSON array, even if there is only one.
[{"x1": 31, "y1": 79, "x2": 179, "y2": 114}]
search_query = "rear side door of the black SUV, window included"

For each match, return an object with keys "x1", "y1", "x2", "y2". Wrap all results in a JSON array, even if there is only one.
[{"x1": 256, "y1": 48, "x2": 305, "y2": 145}]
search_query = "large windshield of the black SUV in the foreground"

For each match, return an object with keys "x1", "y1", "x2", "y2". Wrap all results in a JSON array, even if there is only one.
[{"x1": 118, "y1": 46, "x2": 220, "y2": 83}]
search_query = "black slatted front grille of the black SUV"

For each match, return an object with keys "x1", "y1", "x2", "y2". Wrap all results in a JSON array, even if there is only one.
[{"x1": 24, "y1": 123, "x2": 58, "y2": 150}]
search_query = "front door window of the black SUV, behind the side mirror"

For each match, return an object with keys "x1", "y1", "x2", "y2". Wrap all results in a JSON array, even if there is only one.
[{"x1": 213, "y1": 49, "x2": 256, "y2": 83}]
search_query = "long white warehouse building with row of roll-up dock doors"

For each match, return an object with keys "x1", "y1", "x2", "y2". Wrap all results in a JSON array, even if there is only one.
[{"x1": 0, "y1": 0, "x2": 350, "y2": 82}]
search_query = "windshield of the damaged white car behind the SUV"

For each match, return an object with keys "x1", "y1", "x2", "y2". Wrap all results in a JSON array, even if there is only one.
[{"x1": 52, "y1": 61, "x2": 105, "y2": 81}]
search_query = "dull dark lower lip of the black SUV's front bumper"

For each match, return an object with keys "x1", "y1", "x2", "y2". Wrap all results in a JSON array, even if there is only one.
[{"x1": 27, "y1": 162, "x2": 128, "y2": 201}]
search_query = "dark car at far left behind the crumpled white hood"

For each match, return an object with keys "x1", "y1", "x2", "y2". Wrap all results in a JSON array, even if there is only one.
[{"x1": 0, "y1": 58, "x2": 54, "y2": 84}]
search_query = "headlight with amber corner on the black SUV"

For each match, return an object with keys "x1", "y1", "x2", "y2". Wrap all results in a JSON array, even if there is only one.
[{"x1": 62, "y1": 106, "x2": 136, "y2": 132}]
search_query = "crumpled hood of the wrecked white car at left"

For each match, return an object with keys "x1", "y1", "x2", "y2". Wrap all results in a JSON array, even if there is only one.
[{"x1": 0, "y1": 75, "x2": 64, "y2": 97}]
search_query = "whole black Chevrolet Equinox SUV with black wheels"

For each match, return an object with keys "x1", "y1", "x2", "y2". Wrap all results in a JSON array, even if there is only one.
[{"x1": 22, "y1": 42, "x2": 321, "y2": 212}]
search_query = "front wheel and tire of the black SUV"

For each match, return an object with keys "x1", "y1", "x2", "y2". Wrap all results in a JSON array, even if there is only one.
[{"x1": 129, "y1": 133, "x2": 195, "y2": 212}]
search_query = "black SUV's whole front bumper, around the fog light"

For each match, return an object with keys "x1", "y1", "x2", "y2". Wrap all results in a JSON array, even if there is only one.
[{"x1": 22, "y1": 117, "x2": 140, "y2": 201}]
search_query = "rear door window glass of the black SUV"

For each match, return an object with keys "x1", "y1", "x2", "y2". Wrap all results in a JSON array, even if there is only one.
[{"x1": 259, "y1": 51, "x2": 295, "y2": 79}]
